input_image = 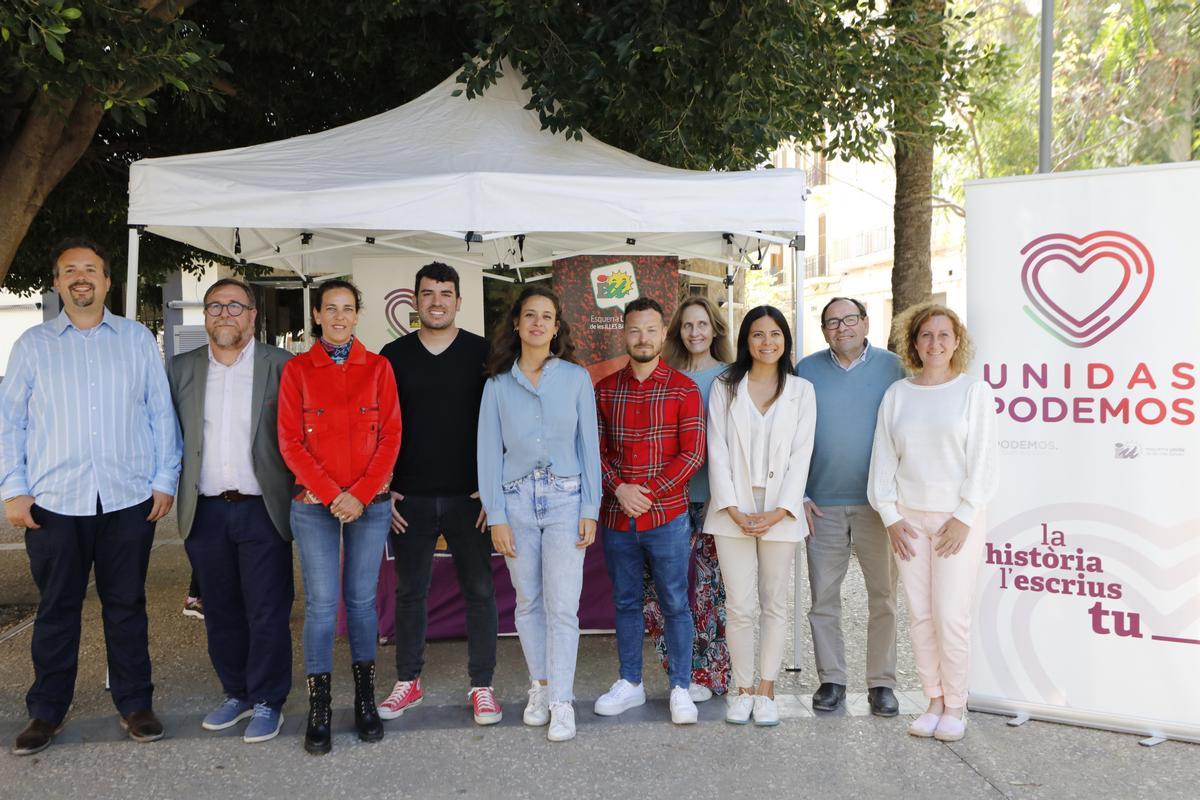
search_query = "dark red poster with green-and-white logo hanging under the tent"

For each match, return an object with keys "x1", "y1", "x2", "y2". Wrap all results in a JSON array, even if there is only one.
[{"x1": 553, "y1": 255, "x2": 679, "y2": 383}]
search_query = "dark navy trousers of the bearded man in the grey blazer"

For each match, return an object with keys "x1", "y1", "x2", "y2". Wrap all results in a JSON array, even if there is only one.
[{"x1": 184, "y1": 497, "x2": 295, "y2": 708}]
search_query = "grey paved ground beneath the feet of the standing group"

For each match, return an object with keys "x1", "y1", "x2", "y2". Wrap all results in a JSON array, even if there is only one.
[{"x1": 0, "y1": 510, "x2": 1200, "y2": 800}]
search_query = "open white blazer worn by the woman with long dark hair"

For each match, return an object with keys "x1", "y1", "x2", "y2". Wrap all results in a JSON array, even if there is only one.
[{"x1": 704, "y1": 375, "x2": 817, "y2": 542}]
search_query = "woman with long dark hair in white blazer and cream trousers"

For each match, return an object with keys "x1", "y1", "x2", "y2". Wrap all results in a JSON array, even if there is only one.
[{"x1": 704, "y1": 306, "x2": 817, "y2": 726}]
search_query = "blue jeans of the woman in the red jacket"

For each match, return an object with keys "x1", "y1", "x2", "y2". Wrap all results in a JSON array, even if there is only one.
[{"x1": 292, "y1": 500, "x2": 391, "y2": 675}]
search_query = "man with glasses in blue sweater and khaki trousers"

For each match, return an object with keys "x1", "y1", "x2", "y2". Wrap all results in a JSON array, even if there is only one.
[{"x1": 796, "y1": 297, "x2": 905, "y2": 716}]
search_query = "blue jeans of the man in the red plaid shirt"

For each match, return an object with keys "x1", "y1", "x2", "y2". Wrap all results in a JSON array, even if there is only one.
[{"x1": 601, "y1": 513, "x2": 696, "y2": 688}]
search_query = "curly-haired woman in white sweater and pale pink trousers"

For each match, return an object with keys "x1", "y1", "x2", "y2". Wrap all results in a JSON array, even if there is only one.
[{"x1": 866, "y1": 303, "x2": 996, "y2": 741}]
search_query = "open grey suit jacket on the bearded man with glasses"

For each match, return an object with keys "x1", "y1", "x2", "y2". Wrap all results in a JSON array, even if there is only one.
[{"x1": 167, "y1": 342, "x2": 296, "y2": 541}]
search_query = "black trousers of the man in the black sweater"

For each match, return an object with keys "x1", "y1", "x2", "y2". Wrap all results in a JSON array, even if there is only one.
[{"x1": 391, "y1": 495, "x2": 498, "y2": 686}]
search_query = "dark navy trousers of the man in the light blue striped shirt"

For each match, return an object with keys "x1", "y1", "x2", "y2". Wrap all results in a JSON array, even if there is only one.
[{"x1": 25, "y1": 498, "x2": 155, "y2": 724}]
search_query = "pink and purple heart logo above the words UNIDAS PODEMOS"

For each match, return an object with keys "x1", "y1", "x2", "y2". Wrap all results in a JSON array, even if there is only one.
[{"x1": 1021, "y1": 230, "x2": 1154, "y2": 348}]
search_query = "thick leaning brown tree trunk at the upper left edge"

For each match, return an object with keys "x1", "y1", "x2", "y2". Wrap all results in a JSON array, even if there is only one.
[{"x1": 0, "y1": 92, "x2": 104, "y2": 285}]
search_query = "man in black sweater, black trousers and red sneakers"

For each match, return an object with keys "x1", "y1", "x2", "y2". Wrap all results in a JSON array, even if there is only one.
[{"x1": 379, "y1": 261, "x2": 500, "y2": 724}]
